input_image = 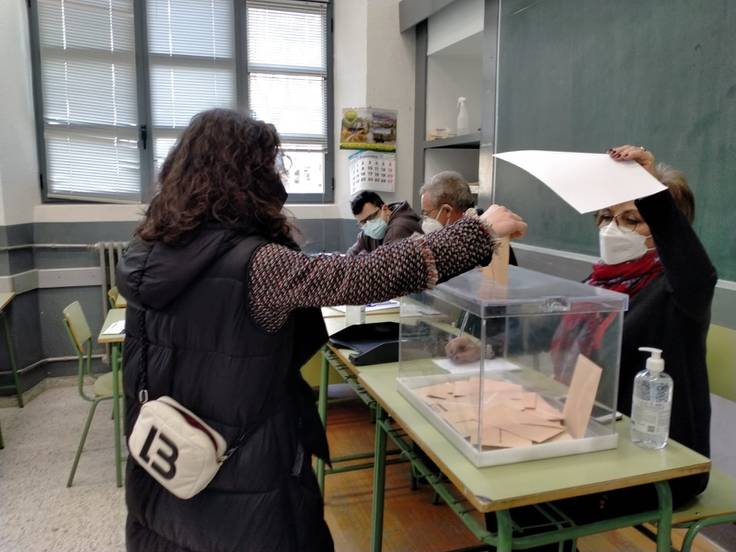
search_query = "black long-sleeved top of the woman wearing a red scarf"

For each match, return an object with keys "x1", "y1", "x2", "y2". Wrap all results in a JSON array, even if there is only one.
[{"x1": 618, "y1": 191, "x2": 718, "y2": 504}]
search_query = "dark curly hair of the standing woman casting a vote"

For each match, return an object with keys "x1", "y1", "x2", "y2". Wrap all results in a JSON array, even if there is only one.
[{"x1": 136, "y1": 109, "x2": 294, "y2": 246}]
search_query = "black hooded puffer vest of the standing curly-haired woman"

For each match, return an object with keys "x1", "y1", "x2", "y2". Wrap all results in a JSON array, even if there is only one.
[{"x1": 118, "y1": 226, "x2": 333, "y2": 552}]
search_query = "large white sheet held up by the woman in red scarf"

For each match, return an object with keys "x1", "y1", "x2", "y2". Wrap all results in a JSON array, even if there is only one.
[{"x1": 495, "y1": 150, "x2": 666, "y2": 213}]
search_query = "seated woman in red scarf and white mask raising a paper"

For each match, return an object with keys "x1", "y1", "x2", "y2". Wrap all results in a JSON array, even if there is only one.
[{"x1": 448, "y1": 145, "x2": 718, "y2": 550}]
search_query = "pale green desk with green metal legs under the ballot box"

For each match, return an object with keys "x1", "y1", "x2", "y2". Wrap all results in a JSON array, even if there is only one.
[{"x1": 358, "y1": 363, "x2": 710, "y2": 552}]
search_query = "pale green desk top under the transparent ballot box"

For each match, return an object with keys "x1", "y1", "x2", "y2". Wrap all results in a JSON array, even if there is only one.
[{"x1": 358, "y1": 363, "x2": 710, "y2": 512}]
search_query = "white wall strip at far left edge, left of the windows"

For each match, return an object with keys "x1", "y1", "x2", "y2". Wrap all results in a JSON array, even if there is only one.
[{"x1": 0, "y1": 0, "x2": 41, "y2": 226}]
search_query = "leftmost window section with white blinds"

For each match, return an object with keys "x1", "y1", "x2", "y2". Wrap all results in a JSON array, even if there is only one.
[{"x1": 37, "y1": 0, "x2": 141, "y2": 201}]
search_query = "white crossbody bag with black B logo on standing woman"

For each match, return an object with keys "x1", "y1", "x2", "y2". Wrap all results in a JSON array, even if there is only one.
[{"x1": 128, "y1": 311, "x2": 248, "y2": 499}]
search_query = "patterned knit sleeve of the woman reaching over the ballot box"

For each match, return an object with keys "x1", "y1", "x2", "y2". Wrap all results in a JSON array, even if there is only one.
[{"x1": 249, "y1": 218, "x2": 493, "y2": 331}]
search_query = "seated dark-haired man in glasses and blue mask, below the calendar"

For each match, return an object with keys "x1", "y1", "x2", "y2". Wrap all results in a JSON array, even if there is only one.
[{"x1": 347, "y1": 190, "x2": 422, "y2": 257}]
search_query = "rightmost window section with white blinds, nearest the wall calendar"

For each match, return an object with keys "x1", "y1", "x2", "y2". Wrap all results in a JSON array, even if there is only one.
[{"x1": 245, "y1": 0, "x2": 327, "y2": 195}]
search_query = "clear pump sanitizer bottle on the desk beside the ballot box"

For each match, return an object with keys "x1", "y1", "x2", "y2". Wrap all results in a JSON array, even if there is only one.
[{"x1": 631, "y1": 347, "x2": 673, "y2": 449}]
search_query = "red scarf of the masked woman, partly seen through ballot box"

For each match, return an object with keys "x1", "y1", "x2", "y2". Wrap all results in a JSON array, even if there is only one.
[{"x1": 550, "y1": 251, "x2": 663, "y2": 383}]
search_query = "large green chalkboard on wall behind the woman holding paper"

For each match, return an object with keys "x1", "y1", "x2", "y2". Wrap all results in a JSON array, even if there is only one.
[{"x1": 495, "y1": 0, "x2": 736, "y2": 280}]
